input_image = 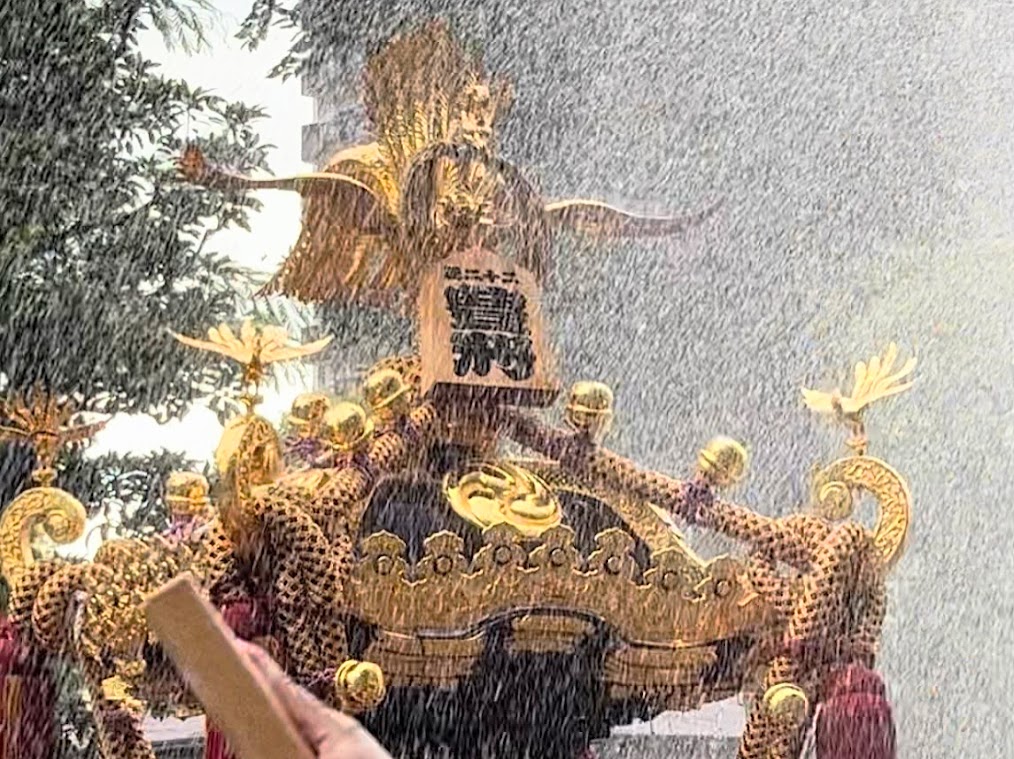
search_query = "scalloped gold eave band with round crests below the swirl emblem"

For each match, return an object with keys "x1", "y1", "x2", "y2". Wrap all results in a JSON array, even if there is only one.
[{"x1": 350, "y1": 525, "x2": 770, "y2": 648}]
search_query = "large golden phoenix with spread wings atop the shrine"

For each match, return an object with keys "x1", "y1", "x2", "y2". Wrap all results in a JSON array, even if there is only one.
[{"x1": 179, "y1": 22, "x2": 718, "y2": 312}]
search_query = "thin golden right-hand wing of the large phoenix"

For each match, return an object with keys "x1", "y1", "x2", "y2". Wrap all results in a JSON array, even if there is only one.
[{"x1": 546, "y1": 200, "x2": 722, "y2": 238}]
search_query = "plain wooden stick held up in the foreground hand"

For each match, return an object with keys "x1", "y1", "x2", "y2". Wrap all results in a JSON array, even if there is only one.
[{"x1": 145, "y1": 575, "x2": 314, "y2": 759}]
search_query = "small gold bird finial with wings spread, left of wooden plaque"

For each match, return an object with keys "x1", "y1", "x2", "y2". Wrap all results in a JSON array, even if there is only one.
[{"x1": 170, "y1": 319, "x2": 332, "y2": 413}]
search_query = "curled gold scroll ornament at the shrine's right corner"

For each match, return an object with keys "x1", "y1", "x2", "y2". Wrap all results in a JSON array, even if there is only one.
[{"x1": 813, "y1": 456, "x2": 912, "y2": 567}]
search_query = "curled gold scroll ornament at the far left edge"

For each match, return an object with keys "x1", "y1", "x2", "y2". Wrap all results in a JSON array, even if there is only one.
[{"x1": 0, "y1": 487, "x2": 86, "y2": 584}]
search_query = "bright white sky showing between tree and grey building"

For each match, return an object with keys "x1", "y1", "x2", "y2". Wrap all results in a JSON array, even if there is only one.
[{"x1": 89, "y1": 0, "x2": 313, "y2": 461}]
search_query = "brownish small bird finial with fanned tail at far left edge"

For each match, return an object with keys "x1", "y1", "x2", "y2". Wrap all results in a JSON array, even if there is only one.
[{"x1": 0, "y1": 386, "x2": 105, "y2": 486}]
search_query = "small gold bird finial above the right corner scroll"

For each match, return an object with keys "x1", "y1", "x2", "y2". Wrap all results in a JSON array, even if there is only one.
[{"x1": 803, "y1": 343, "x2": 916, "y2": 456}]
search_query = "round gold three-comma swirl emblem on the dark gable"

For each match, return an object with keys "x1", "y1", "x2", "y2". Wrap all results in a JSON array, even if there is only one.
[{"x1": 443, "y1": 462, "x2": 563, "y2": 538}]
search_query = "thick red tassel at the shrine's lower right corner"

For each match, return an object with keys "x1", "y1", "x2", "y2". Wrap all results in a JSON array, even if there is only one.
[{"x1": 816, "y1": 664, "x2": 897, "y2": 759}]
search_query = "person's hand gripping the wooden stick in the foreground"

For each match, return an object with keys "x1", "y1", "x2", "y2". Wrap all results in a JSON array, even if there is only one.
[{"x1": 236, "y1": 640, "x2": 391, "y2": 759}]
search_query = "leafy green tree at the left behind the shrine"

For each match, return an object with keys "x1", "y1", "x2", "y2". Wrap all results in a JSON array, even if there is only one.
[{"x1": 0, "y1": 0, "x2": 265, "y2": 528}]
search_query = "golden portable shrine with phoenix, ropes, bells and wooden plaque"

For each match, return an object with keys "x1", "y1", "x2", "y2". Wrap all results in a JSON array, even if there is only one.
[{"x1": 0, "y1": 16, "x2": 914, "y2": 759}]
